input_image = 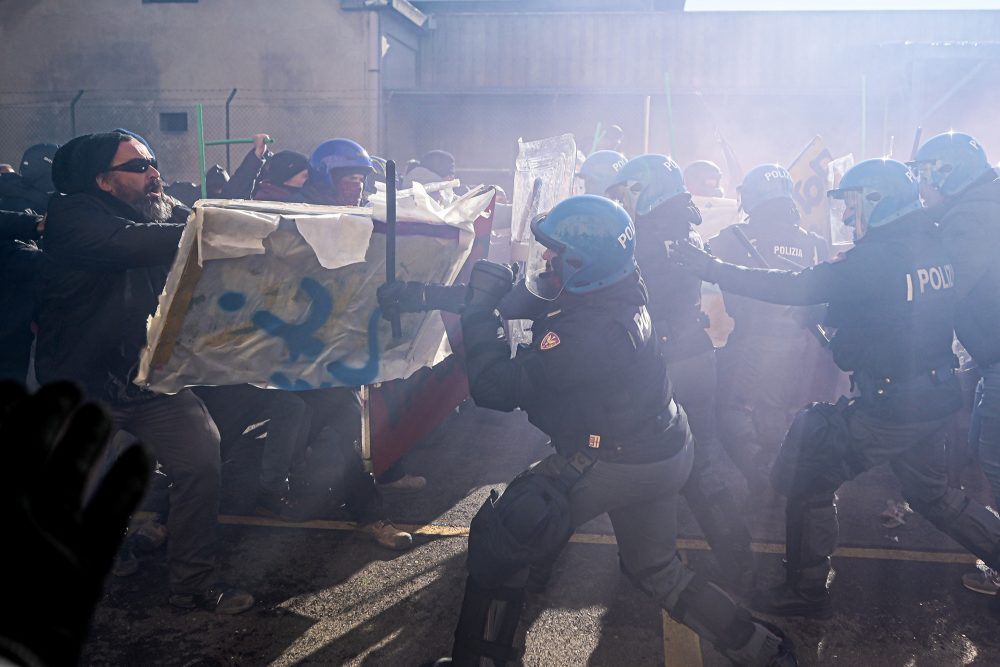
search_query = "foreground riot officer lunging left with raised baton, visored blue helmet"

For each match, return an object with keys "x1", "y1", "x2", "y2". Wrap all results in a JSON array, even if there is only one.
[{"x1": 379, "y1": 195, "x2": 797, "y2": 665}]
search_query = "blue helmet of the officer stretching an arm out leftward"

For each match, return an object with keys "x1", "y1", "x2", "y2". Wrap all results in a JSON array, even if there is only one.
[{"x1": 827, "y1": 158, "x2": 921, "y2": 239}]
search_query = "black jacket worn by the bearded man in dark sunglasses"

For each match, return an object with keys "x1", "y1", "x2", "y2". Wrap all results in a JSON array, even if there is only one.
[{"x1": 35, "y1": 188, "x2": 190, "y2": 405}]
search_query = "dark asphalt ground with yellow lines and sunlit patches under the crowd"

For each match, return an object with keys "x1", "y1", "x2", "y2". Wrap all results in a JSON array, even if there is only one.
[{"x1": 83, "y1": 407, "x2": 1000, "y2": 667}]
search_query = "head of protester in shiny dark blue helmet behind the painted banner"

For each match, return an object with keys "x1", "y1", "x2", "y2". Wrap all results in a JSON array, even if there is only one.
[{"x1": 302, "y1": 138, "x2": 375, "y2": 206}]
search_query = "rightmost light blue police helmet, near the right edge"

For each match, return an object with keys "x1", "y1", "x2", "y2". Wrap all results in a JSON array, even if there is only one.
[{"x1": 910, "y1": 132, "x2": 990, "y2": 197}]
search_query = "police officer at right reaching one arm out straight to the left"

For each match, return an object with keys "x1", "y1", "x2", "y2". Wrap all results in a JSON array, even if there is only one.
[{"x1": 676, "y1": 159, "x2": 1000, "y2": 618}]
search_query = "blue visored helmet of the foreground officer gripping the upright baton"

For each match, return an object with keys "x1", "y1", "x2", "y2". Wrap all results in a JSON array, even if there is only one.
[{"x1": 526, "y1": 195, "x2": 636, "y2": 300}]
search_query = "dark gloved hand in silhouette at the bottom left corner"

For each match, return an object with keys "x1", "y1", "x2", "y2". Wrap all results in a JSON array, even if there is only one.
[{"x1": 0, "y1": 382, "x2": 152, "y2": 665}]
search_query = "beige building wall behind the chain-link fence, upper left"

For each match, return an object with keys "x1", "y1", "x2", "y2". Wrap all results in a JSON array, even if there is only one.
[{"x1": 0, "y1": 0, "x2": 380, "y2": 180}]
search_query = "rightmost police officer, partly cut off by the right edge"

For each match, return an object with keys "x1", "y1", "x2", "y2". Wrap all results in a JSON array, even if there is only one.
[{"x1": 911, "y1": 132, "x2": 1000, "y2": 600}]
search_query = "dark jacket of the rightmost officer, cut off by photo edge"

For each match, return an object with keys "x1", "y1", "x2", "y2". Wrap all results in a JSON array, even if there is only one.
[{"x1": 931, "y1": 170, "x2": 1000, "y2": 367}]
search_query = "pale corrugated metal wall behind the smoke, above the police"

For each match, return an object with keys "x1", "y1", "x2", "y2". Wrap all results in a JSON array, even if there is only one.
[{"x1": 386, "y1": 11, "x2": 1000, "y2": 189}]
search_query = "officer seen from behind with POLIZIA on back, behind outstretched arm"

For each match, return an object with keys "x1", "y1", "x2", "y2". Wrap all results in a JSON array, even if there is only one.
[{"x1": 710, "y1": 164, "x2": 828, "y2": 489}]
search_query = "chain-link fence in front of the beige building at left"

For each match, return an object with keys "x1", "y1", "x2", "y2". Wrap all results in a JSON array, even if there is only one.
[{"x1": 0, "y1": 90, "x2": 378, "y2": 181}]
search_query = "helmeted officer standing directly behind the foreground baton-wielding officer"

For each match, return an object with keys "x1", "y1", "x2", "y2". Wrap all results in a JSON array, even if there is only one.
[{"x1": 619, "y1": 153, "x2": 753, "y2": 592}]
